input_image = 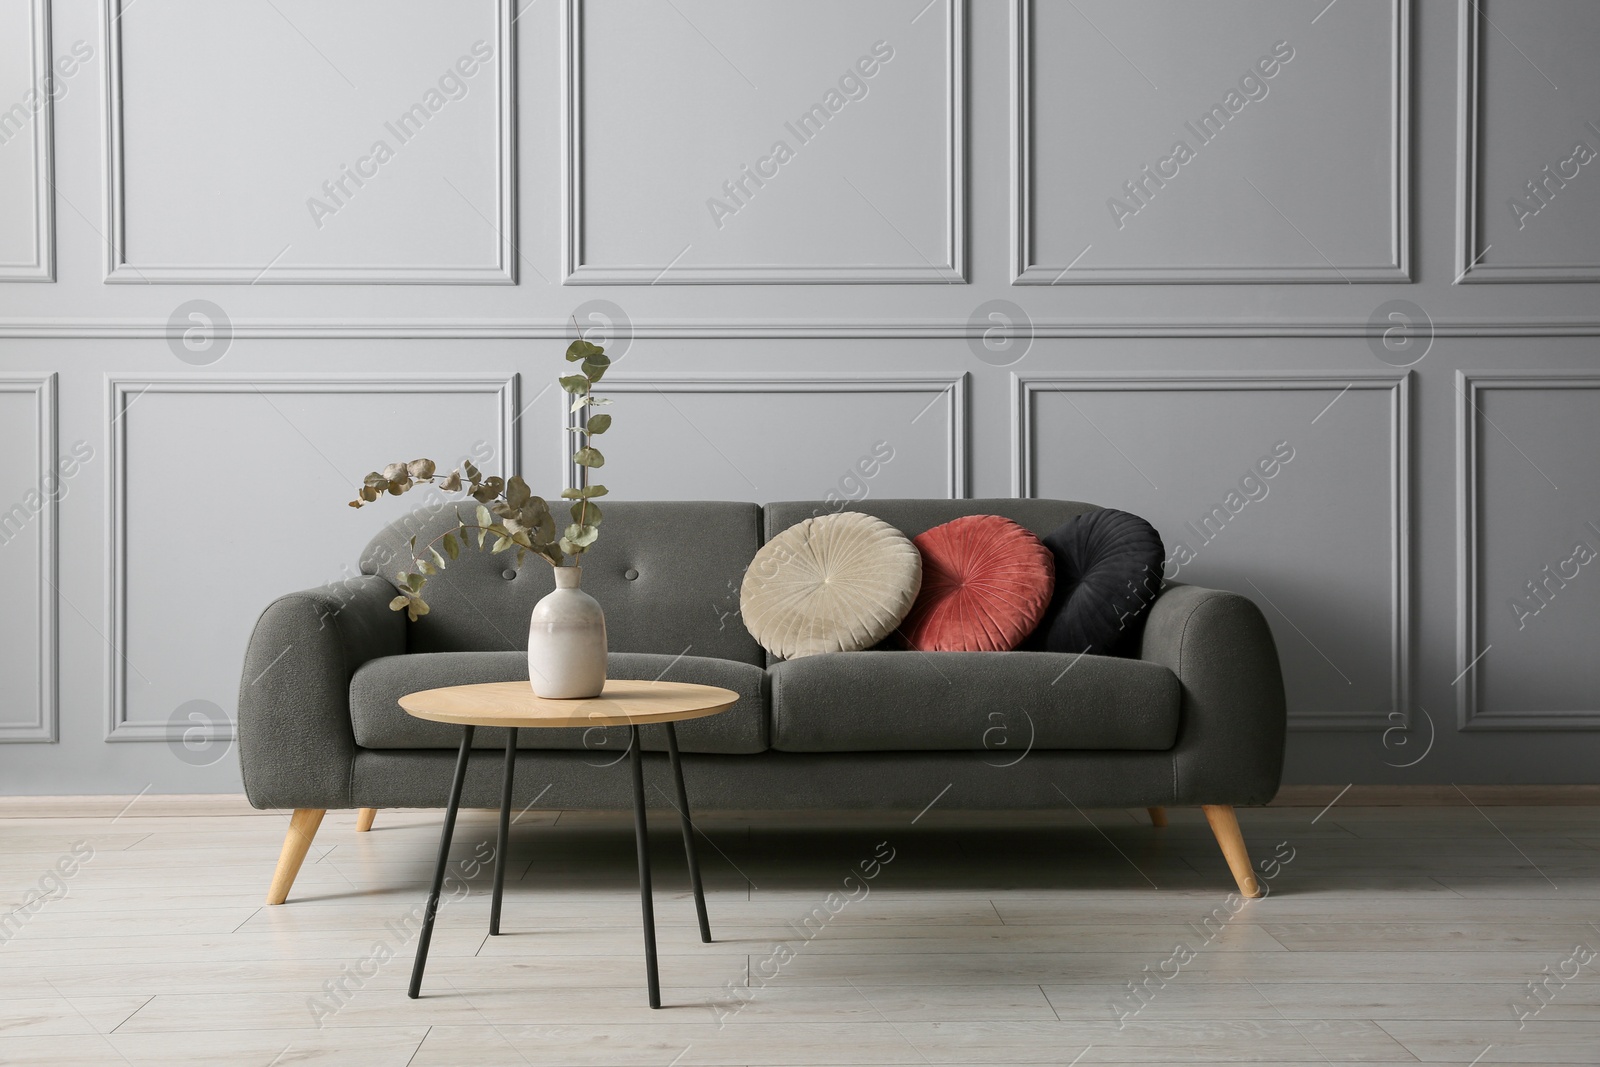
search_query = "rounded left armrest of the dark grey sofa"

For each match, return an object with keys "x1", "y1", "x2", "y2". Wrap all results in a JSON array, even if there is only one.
[{"x1": 238, "y1": 574, "x2": 406, "y2": 808}]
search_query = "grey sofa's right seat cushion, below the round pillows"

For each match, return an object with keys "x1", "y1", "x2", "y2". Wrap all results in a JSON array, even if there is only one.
[{"x1": 771, "y1": 651, "x2": 1181, "y2": 760}]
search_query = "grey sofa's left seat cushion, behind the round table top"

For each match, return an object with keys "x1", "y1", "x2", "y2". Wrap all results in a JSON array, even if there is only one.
[{"x1": 350, "y1": 653, "x2": 768, "y2": 755}]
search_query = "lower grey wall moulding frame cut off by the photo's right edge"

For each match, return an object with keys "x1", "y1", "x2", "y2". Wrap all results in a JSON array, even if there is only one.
[{"x1": 1454, "y1": 370, "x2": 1600, "y2": 731}]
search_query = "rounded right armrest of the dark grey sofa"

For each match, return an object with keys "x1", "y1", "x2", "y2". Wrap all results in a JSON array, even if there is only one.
[{"x1": 1139, "y1": 585, "x2": 1288, "y2": 805}]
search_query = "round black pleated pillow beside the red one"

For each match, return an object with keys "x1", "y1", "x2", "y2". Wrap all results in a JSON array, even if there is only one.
[{"x1": 1029, "y1": 507, "x2": 1166, "y2": 656}]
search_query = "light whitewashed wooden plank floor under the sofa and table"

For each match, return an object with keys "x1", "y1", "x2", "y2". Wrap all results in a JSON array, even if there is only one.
[{"x1": 0, "y1": 798, "x2": 1600, "y2": 1067}]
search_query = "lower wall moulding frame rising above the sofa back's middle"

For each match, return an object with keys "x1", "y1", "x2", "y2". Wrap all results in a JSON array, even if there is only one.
[{"x1": 585, "y1": 373, "x2": 968, "y2": 501}]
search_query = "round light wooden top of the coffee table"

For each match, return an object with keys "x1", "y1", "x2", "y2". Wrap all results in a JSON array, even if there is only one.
[{"x1": 400, "y1": 678, "x2": 739, "y2": 728}]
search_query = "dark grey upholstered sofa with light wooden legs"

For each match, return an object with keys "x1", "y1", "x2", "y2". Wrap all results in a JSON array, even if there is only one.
[{"x1": 238, "y1": 499, "x2": 1285, "y2": 904}]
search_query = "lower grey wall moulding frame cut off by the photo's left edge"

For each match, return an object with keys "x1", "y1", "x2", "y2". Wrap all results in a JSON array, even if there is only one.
[{"x1": 0, "y1": 373, "x2": 61, "y2": 744}]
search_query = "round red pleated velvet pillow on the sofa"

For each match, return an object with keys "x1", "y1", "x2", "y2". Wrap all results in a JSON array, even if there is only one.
[{"x1": 901, "y1": 515, "x2": 1056, "y2": 653}]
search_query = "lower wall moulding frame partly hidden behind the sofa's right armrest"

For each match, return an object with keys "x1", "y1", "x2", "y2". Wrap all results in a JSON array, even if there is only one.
[{"x1": 1011, "y1": 373, "x2": 1411, "y2": 729}]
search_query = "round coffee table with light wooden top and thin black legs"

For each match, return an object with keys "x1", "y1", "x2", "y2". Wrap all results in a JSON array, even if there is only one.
[{"x1": 400, "y1": 680, "x2": 739, "y2": 1008}]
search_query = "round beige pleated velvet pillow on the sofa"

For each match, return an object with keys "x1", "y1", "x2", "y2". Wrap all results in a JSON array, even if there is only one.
[{"x1": 739, "y1": 512, "x2": 922, "y2": 659}]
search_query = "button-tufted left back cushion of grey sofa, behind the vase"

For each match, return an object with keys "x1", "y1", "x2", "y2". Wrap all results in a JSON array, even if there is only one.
[{"x1": 362, "y1": 499, "x2": 766, "y2": 665}]
